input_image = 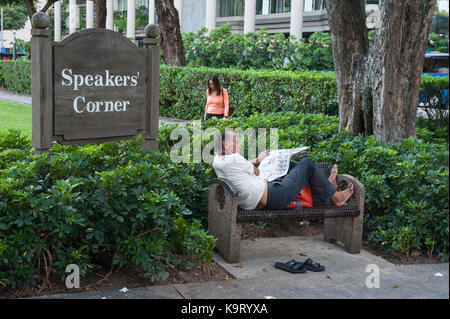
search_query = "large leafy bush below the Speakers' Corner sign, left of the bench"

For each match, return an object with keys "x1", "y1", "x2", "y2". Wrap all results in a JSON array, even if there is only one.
[{"x1": 0, "y1": 131, "x2": 214, "y2": 286}]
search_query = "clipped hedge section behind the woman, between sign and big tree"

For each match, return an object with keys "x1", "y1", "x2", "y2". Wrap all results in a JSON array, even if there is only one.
[{"x1": 160, "y1": 66, "x2": 337, "y2": 119}]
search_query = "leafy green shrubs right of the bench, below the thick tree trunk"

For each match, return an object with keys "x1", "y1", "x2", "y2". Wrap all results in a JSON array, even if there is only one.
[{"x1": 313, "y1": 129, "x2": 449, "y2": 260}]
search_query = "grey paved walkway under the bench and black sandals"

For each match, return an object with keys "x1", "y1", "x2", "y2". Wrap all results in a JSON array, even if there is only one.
[{"x1": 33, "y1": 236, "x2": 449, "y2": 299}]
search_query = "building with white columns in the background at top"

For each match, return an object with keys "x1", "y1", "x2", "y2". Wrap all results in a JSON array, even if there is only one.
[{"x1": 49, "y1": 0, "x2": 379, "y2": 41}]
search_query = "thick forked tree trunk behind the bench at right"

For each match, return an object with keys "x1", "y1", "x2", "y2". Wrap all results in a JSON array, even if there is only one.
[{"x1": 326, "y1": 0, "x2": 436, "y2": 142}]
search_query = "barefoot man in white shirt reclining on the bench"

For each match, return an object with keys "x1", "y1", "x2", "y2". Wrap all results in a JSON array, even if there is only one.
[{"x1": 213, "y1": 129, "x2": 353, "y2": 214}]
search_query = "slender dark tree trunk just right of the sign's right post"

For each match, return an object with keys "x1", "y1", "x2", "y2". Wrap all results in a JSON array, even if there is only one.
[{"x1": 155, "y1": 0, "x2": 186, "y2": 66}]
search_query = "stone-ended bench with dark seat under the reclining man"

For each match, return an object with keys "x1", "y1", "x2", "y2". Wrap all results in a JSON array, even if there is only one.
[{"x1": 208, "y1": 163, "x2": 365, "y2": 263}]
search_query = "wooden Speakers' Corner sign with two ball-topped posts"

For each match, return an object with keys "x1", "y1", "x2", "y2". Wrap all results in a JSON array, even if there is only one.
[{"x1": 31, "y1": 12, "x2": 160, "y2": 153}]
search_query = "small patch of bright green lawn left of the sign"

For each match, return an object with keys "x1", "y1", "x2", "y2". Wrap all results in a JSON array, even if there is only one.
[{"x1": 0, "y1": 101, "x2": 31, "y2": 136}]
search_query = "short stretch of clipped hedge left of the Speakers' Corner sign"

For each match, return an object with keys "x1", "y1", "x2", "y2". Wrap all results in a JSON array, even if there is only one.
[{"x1": 0, "y1": 60, "x2": 31, "y2": 94}]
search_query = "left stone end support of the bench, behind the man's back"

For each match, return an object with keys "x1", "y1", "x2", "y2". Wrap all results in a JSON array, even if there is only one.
[{"x1": 208, "y1": 184, "x2": 241, "y2": 263}]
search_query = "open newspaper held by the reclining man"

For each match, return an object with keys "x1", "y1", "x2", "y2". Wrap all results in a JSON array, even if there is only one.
[{"x1": 258, "y1": 147, "x2": 309, "y2": 182}]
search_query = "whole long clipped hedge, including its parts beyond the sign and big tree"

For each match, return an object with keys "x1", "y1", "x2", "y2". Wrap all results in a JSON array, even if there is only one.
[{"x1": 0, "y1": 61, "x2": 449, "y2": 123}]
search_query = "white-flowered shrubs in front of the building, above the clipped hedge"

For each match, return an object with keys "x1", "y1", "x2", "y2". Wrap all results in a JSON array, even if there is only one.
[{"x1": 183, "y1": 23, "x2": 333, "y2": 71}]
